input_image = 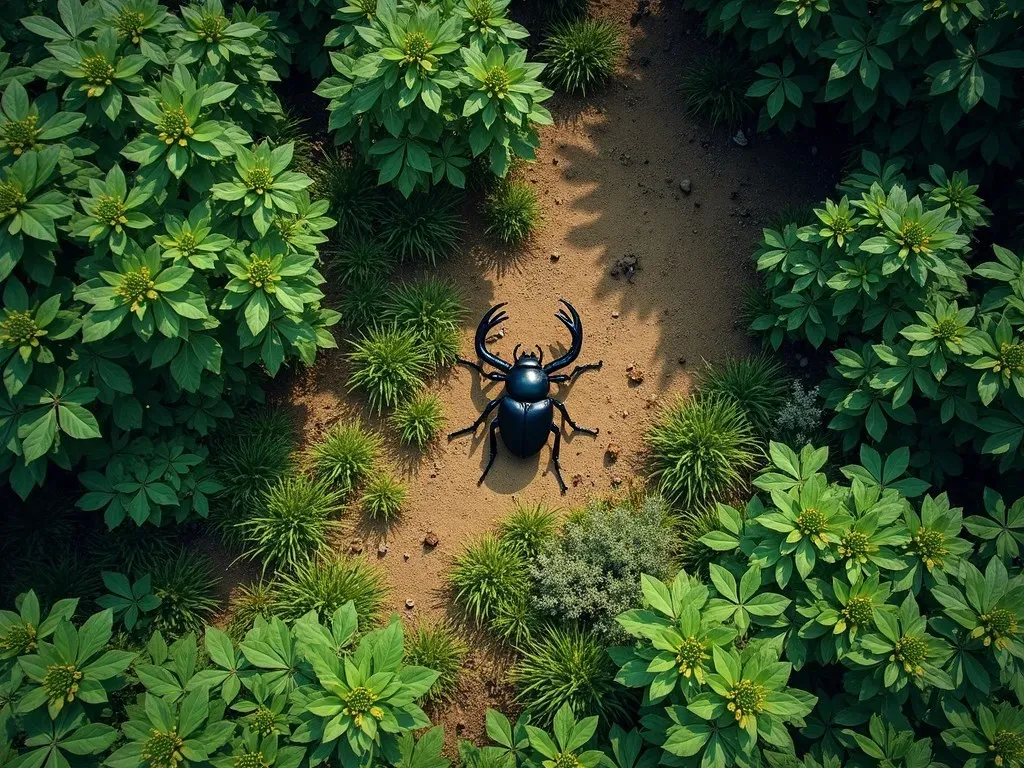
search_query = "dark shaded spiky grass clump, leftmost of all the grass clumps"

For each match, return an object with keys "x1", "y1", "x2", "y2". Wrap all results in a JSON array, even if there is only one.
[{"x1": 150, "y1": 550, "x2": 219, "y2": 638}]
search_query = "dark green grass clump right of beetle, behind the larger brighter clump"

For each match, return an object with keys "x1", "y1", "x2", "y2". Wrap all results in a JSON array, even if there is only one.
[{"x1": 699, "y1": 354, "x2": 790, "y2": 436}]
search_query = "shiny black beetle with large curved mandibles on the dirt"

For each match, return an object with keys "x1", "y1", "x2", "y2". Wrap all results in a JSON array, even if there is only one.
[{"x1": 449, "y1": 299, "x2": 604, "y2": 494}]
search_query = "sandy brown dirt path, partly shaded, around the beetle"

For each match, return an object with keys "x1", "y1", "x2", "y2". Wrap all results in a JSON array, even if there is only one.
[{"x1": 276, "y1": 0, "x2": 830, "y2": 743}]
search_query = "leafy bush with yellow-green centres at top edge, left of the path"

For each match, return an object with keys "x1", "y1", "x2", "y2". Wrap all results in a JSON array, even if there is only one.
[{"x1": 316, "y1": 0, "x2": 551, "y2": 198}]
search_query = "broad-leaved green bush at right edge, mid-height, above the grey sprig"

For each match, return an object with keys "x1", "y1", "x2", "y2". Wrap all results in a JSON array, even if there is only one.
[{"x1": 753, "y1": 153, "x2": 1024, "y2": 480}]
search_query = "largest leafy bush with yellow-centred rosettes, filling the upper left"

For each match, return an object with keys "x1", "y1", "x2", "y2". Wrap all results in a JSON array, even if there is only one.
[{"x1": 0, "y1": 2, "x2": 337, "y2": 505}]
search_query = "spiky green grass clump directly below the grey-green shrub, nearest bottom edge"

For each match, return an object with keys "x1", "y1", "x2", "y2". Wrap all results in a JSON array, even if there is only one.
[{"x1": 511, "y1": 626, "x2": 626, "y2": 725}]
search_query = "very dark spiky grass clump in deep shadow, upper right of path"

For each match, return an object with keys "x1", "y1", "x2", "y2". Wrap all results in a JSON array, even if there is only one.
[{"x1": 680, "y1": 52, "x2": 753, "y2": 128}]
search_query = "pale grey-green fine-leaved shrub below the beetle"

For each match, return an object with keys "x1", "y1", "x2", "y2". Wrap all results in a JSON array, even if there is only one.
[{"x1": 530, "y1": 496, "x2": 672, "y2": 638}]
